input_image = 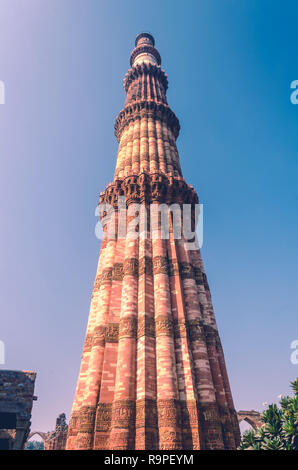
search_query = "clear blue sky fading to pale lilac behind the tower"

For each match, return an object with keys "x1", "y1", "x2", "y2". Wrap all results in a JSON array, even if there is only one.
[{"x1": 0, "y1": 0, "x2": 298, "y2": 431}]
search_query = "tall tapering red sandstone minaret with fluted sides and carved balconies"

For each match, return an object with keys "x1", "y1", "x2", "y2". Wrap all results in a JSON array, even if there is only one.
[{"x1": 67, "y1": 33, "x2": 240, "y2": 450}]
